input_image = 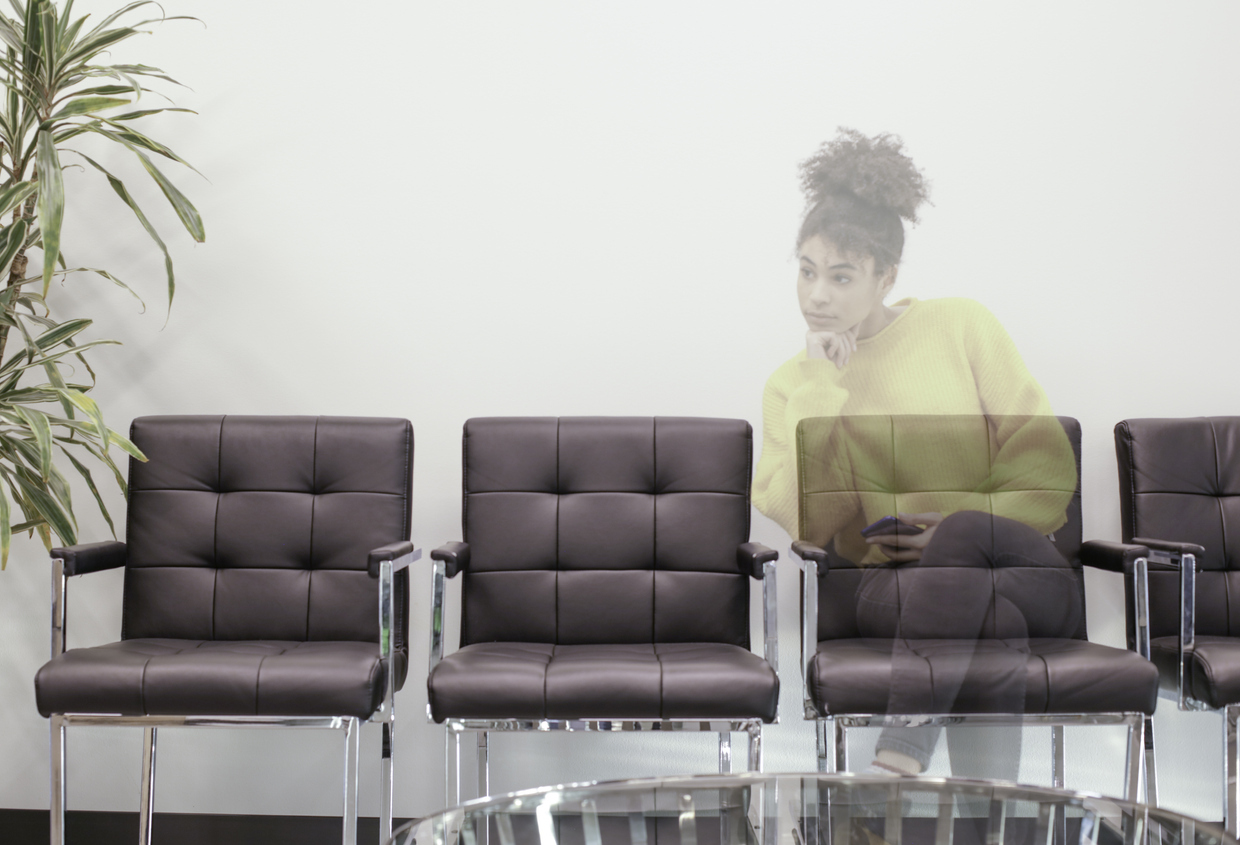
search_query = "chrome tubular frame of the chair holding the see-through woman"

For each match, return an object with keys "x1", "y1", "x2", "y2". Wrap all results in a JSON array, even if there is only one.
[{"x1": 794, "y1": 552, "x2": 1155, "y2": 803}]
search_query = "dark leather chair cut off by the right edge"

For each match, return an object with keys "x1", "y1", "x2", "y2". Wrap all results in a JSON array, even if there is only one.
[{"x1": 1115, "y1": 417, "x2": 1240, "y2": 835}]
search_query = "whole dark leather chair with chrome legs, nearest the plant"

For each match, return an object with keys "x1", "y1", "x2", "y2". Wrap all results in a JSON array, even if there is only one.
[{"x1": 35, "y1": 417, "x2": 418, "y2": 845}]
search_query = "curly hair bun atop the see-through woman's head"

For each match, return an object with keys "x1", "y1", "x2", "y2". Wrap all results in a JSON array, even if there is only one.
[{"x1": 801, "y1": 127, "x2": 930, "y2": 223}]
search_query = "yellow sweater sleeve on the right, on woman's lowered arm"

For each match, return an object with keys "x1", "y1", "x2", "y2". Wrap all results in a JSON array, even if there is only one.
[{"x1": 965, "y1": 303, "x2": 1076, "y2": 534}]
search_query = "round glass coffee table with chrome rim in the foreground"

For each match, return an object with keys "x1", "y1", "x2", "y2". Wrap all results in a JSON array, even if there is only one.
[{"x1": 391, "y1": 773, "x2": 1240, "y2": 845}]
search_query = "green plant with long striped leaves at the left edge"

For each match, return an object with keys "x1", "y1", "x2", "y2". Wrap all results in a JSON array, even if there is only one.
[{"x1": 0, "y1": 0, "x2": 205, "y2": 567}]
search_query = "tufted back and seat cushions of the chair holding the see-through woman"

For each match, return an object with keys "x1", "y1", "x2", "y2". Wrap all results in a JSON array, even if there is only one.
[{"x1": 799, "y1": 416, "x2": 1158, "y2": 715}]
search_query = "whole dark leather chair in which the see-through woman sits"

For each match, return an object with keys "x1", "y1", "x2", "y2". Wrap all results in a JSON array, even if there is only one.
[{"x1": 792, "y1": 416, "x2": 1157, "y2": 799}]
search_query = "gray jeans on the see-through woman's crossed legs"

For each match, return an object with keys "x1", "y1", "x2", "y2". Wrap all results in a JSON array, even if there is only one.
[{"x1": 857, "y1": 511, "x2": 1081, "y2": 780}]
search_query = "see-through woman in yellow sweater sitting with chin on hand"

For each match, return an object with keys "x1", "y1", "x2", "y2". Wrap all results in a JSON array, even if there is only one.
[{"x1": 753, "y1": 129, "x2": 1084, "y2": 779}]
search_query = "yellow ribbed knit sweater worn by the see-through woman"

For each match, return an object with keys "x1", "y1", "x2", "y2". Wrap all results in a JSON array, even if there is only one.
[{"x1": 753, "y1": 292, "x2": 1076, "y2": 563}]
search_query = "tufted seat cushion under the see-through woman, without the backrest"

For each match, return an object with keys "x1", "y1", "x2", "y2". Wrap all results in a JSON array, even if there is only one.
[{"x1": 810, "y1": 638, "x2": 1158, "y2": 713}]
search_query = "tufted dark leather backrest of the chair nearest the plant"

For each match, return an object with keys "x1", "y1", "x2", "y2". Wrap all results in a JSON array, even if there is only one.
[{"x1": 123, "y1": 416, "x2": 413, "y2": 649}]
